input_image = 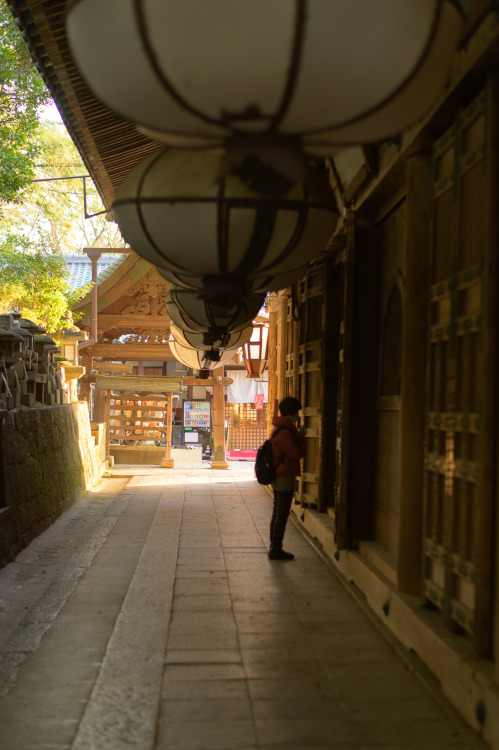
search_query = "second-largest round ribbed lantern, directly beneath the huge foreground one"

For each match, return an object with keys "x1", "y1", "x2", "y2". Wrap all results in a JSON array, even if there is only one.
[{"x1": 113, "y1": 149, "x2": 338, "y2": 292}]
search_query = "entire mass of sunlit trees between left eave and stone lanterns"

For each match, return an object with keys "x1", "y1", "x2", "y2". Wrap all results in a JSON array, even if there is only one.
[{"x1": 0, "y1": 0, "x2": 124, "y2": 332}]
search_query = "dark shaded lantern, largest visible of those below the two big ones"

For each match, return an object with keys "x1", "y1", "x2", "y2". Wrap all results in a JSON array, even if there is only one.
[{"x1": 165, "y1": 287, "x2": 265, "y2": 339}]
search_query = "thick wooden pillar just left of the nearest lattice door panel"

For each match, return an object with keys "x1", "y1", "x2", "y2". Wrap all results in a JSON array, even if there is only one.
[{"x1": 397, "y1": 153, "x2": 431, "y2": 594}]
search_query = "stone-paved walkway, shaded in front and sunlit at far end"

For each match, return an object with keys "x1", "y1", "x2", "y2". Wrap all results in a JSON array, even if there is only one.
[{"x1": 0, "y1": 462, "x2": 486, "y2": 750}]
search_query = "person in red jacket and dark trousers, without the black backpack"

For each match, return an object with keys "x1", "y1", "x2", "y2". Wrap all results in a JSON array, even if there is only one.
[{"x1": 269, "y1": 396, "x2": 305, "y2": 560}]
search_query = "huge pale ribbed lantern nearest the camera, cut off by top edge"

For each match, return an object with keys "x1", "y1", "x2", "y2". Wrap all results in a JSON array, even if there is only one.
[{"x1": 67, "y1": 0, "x2": 463, "y2": 155}]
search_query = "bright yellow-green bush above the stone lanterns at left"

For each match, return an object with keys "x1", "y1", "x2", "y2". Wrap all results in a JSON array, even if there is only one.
[{"x1": 0, "y1": 236, "x2": 89, "y2": 332}]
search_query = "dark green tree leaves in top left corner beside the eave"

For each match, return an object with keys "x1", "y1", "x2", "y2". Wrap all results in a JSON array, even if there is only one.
[{"x1": 0, "y1": 0, "x2": 50, "y2": 201}]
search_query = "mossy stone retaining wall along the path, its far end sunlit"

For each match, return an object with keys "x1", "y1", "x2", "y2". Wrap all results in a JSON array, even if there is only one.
[{"x1": 0, "y1": 402, "x2": 104, "y2": 565}]
